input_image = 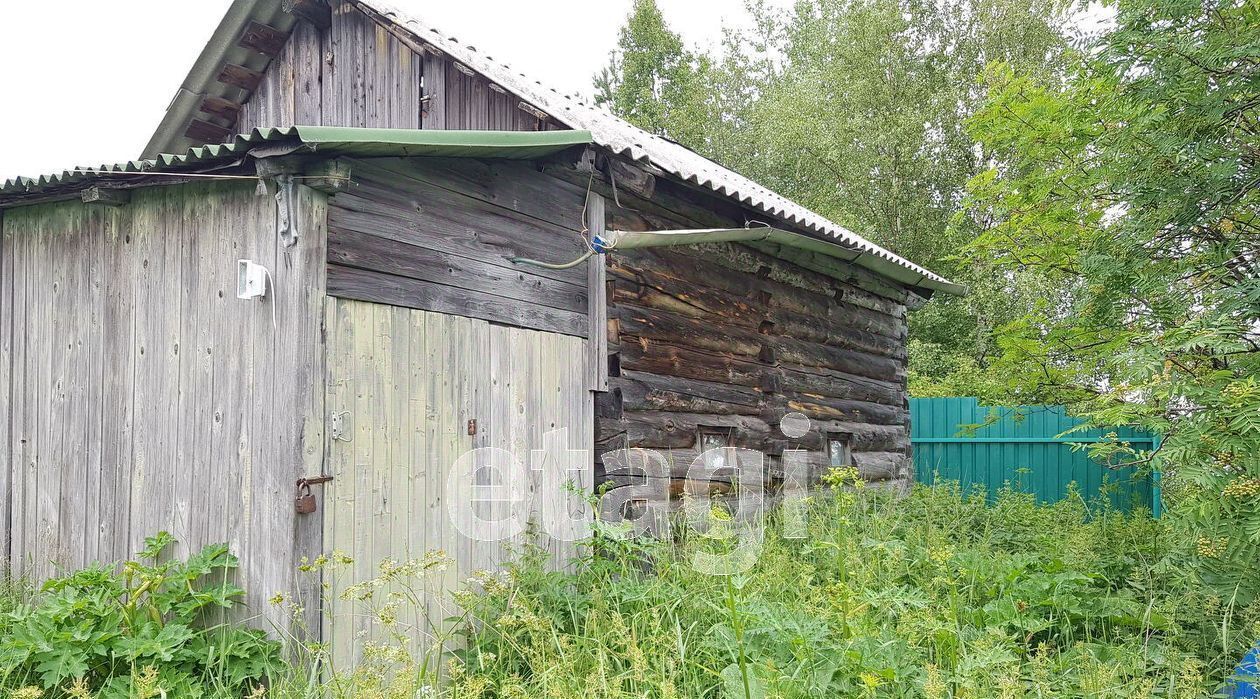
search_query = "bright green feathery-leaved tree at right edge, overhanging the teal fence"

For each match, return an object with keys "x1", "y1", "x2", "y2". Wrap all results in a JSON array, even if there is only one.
[{"x1": 965, "y1": 0, "x2": 1260, "y2": 603}]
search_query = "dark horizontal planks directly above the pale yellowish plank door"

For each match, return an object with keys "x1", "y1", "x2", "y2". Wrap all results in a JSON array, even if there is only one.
[{"x1": 328, "y1": 157, "x2": 590, "y2": 336}]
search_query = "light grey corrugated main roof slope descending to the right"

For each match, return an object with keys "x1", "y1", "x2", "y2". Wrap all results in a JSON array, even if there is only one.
[{"x1": 350, "y1": 0, "x2": 964, "y2": 293}]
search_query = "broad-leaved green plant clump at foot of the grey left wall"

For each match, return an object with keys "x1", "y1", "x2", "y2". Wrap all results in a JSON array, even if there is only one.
[{"x1": 0, "y1": 531, "x2": 281, "y2": 699}]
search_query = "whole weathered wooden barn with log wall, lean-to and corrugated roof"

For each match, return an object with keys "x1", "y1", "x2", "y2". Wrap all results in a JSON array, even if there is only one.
[{"x1": 0, "y1": 0, "x2": 960, "y2": 645}]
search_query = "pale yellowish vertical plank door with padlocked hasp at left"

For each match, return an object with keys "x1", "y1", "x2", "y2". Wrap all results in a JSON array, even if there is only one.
[{"x1": 324, "y1": 298, "x2": 584, "y2": 664}]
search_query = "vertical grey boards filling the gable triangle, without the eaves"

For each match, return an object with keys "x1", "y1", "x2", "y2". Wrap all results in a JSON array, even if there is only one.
[{"x1": 237, "y1": 0, "x2": 542, "y2": 132}]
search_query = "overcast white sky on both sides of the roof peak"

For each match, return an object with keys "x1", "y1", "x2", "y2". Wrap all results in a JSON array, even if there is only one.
[{"x1": 0, "y1": 0, "x2": 790, "y2": 179}]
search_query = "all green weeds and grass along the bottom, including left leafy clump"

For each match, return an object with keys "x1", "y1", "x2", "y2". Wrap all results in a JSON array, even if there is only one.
[{"x1": 0, "y1": 481, "x2": 1260, "y2": 699}]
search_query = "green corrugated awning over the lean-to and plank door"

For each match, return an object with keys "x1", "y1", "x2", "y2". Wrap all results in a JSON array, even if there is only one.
[{"x1": 0, "y1": 126, "x2": 592, "y2": 207}]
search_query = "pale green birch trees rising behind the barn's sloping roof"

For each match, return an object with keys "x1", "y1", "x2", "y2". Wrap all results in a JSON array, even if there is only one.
[{"x1": 596, "y1": 0, "x2": 1065, "y2": 394}]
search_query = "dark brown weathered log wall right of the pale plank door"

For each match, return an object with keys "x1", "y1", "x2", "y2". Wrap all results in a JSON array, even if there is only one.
[{"x1": 584, "y1": 165, "x2": 912, "y2": 495}]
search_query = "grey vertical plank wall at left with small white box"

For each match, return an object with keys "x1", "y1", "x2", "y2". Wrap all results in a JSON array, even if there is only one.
[{"x1": 0, "y1": 183, "x2": 326, "y2": 632}]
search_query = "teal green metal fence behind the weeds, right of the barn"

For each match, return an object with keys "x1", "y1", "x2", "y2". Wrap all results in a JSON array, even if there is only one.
[{"x1": 910, "y1": 398, "x2": 1159, "y2": 514}]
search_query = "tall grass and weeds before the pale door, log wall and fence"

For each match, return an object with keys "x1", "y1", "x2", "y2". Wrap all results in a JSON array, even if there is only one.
[{"x1": 0, "y1": 472, "x2": 1260, "y2": 699}]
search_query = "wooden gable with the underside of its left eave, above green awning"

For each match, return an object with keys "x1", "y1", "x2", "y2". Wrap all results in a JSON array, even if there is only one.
[{"x1": 183, "y1": 0, "x2": 561, "y2": 145}]
